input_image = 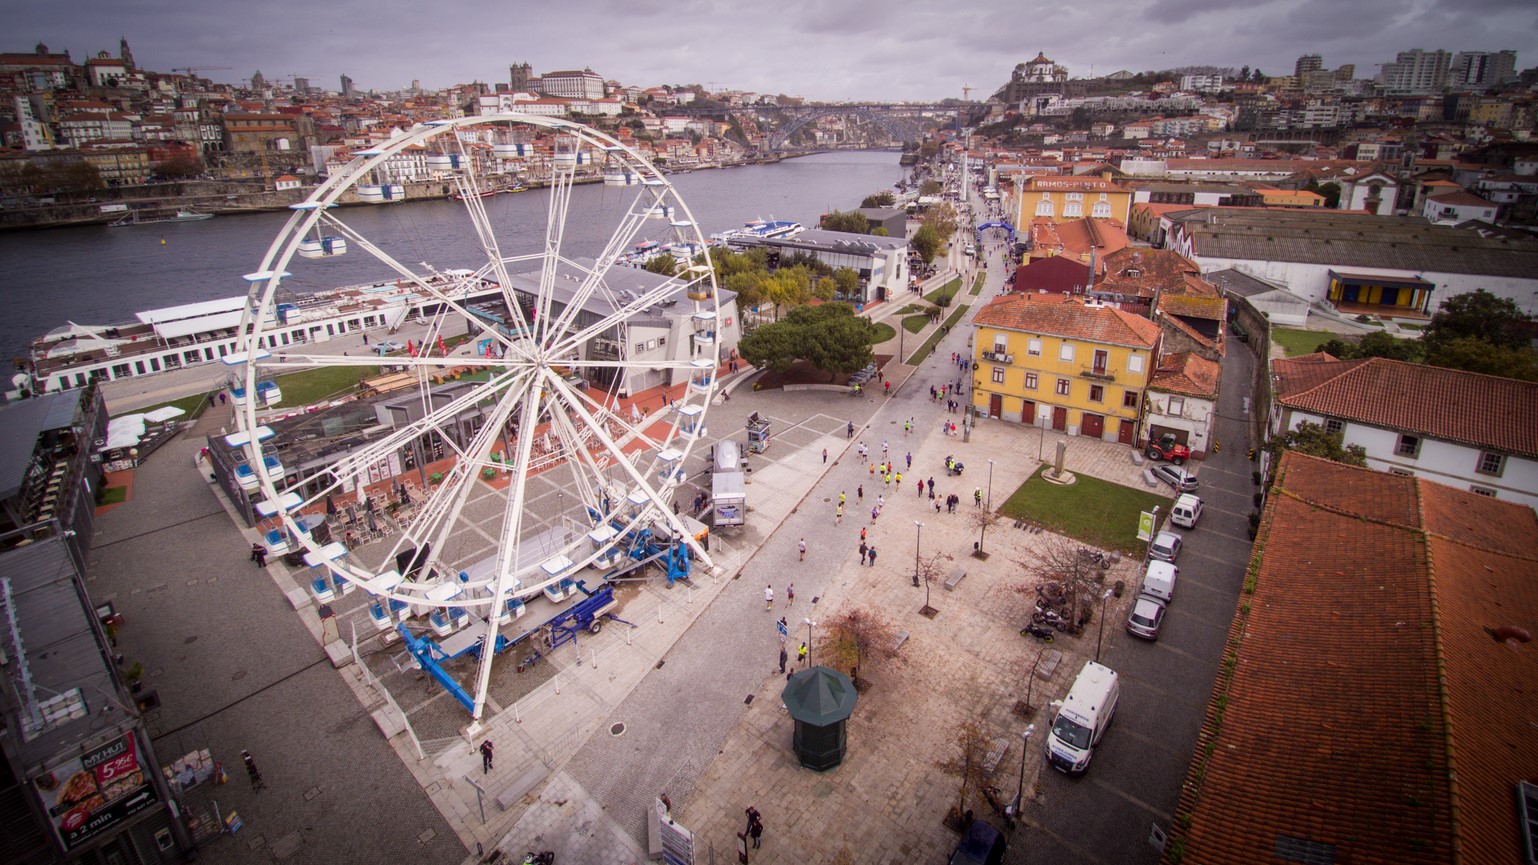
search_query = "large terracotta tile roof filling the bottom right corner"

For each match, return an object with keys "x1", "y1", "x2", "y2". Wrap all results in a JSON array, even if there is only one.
[{"x1": 1173, "y1": 453, "x2": 1538, "y2": 865}]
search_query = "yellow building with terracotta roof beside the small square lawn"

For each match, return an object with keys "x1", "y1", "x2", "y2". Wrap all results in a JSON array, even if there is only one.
[{"x1": 972, "y1": 294, "x2": 1160, "y2": 445}]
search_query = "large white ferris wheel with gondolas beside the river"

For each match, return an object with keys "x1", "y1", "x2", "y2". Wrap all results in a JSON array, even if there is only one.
[{"x1": 226, "y1": 114, "x2": 721, "y2": 720}]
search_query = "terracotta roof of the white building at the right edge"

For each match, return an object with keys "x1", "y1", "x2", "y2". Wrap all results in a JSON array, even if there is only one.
[{"x1": 1272, "y1": 354, "x2": 1538, "y2": 457}]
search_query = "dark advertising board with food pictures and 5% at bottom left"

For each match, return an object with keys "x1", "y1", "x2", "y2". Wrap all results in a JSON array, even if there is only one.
[{"x1": 32, "y1": 734, "x2": 157, "y2": 850}]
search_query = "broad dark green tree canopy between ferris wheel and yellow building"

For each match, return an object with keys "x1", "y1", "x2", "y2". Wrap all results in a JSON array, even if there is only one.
[{"x1": 737, "y1": 303, "x2": 875, "y2": 380}]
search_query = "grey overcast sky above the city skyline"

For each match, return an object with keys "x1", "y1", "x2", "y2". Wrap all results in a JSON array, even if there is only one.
[{"x1": 12, "y1": 0, "x2": 1538, "y2": 100}]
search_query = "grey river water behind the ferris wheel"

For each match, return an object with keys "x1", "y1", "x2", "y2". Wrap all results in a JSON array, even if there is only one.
[{"x1": 0, "y1": 151, "x2": 903, "y2": 357}]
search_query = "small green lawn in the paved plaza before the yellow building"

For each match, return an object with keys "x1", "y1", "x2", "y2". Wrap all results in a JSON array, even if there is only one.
[{"x1": 998, "y1": 465, "x2": 1169, "y2": 554}]
